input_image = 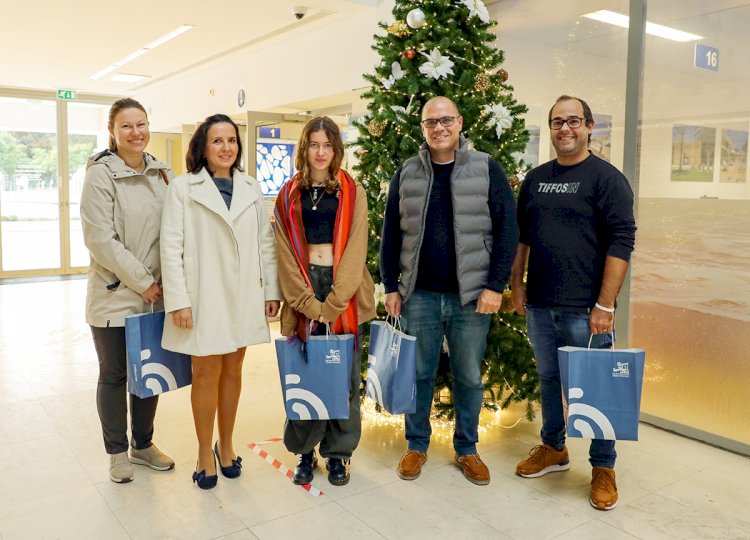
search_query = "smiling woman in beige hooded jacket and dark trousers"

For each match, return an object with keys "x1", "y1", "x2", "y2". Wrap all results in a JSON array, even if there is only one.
[{"x1": 81, "y1": 98, "x2": 174, "y2": 483}]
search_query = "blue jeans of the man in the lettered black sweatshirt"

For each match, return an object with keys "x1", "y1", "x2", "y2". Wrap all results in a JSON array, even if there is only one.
[{"x1": 526, "y1": 307, "x2": 617, "y2": 468}]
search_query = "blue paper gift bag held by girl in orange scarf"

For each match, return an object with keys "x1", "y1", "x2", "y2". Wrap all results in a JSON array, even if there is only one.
[{"x1": 276, "y1": 334, "x2": 354, "y2": 420}]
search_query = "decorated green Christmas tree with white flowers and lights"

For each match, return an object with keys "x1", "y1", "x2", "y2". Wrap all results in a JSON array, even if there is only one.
[{"x1": 354, "y1": 0, "x2": 539, "y2": 419}]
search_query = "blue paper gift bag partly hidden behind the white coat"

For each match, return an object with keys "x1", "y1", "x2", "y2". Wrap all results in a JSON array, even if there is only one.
[{"x1": 125, "y1": 311, "x2": 193, "y2": 398}]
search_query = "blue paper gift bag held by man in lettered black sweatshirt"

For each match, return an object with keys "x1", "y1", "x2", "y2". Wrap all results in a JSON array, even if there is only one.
[{"x1": 557, "y1": 347, "x2": 646, "y2": 441}]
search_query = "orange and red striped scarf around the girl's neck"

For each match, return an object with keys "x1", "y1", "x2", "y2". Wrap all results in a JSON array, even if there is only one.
[{"x1": 274, "y1": 169, "x2": 357, "y2": 343}]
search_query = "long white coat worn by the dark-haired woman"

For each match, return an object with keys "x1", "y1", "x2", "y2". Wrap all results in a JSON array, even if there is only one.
[{"x1": 161, "y1": 168, "x2": 281, "y2": 356}]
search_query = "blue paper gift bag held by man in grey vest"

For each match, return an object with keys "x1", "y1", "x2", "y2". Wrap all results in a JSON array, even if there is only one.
[{"x1": 367, "y1": 321, "x2": 417, "y2": 414}]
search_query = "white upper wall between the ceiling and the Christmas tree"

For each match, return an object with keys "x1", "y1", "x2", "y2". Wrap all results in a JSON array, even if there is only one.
[{"x1": 135, "y1": 0, "x2": 393, "y2": 131}]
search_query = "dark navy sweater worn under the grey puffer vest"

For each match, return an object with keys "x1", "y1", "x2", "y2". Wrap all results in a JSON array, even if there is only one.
[{"x1": 380, "y1": 159, "x2": 518, "y2": 293}]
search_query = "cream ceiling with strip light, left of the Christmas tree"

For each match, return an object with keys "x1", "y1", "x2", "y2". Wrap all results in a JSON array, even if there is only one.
[{"x1": 0, "y1": 0, "x2": 382, "y2": 95}]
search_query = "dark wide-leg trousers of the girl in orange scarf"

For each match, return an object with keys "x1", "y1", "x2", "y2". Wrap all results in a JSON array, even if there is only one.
[{"x1": 284, "y1": 264, "x2": 362, "y2": 459}]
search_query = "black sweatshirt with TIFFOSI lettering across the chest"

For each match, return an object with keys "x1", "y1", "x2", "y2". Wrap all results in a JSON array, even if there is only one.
[{"x1": 518, "y1": 155, "x2": 635, "y2": 309}]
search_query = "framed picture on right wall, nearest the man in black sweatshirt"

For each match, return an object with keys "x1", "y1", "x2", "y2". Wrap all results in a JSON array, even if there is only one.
[{"x1": 671, "y1": 124, "x2": 716, "y2": 182}]
